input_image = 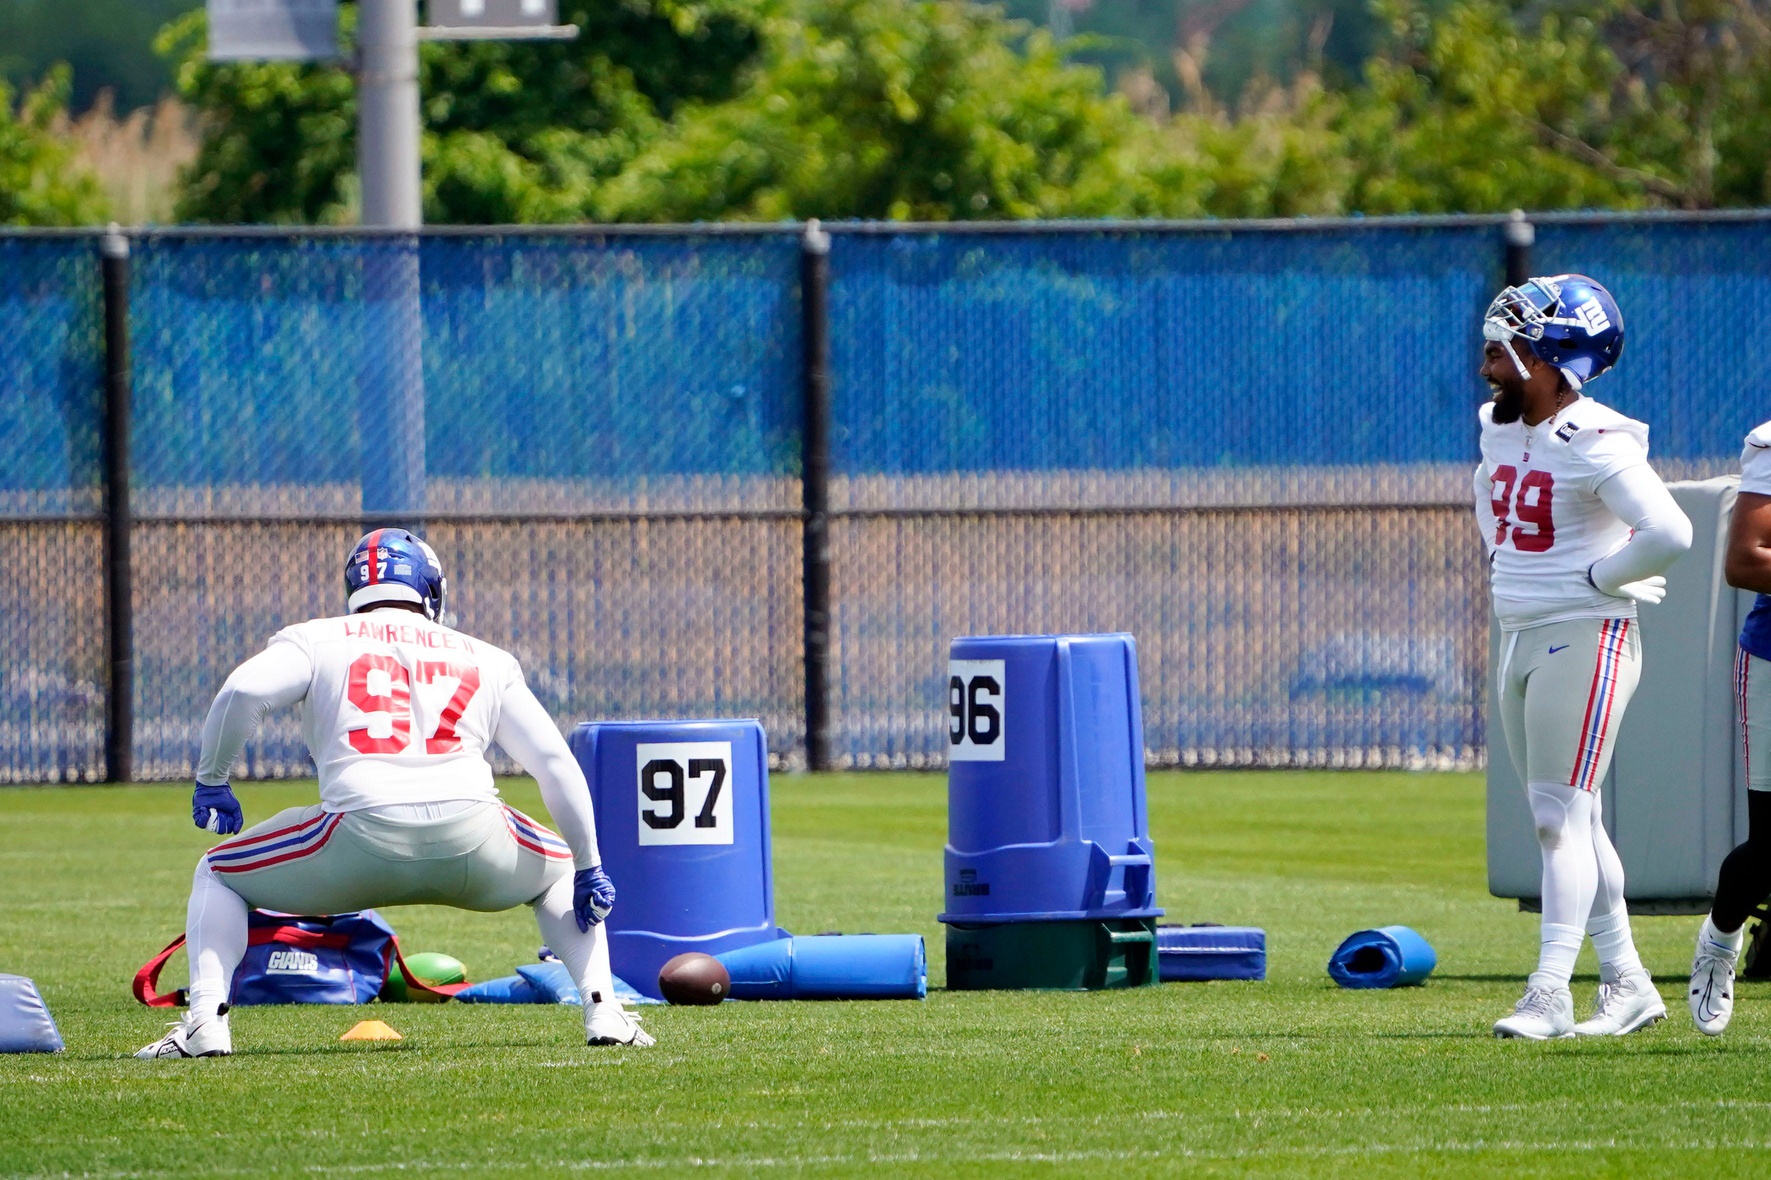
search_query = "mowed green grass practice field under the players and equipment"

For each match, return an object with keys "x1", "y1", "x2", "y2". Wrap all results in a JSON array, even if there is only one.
[{"x1": 0, "y1": 772, "x2": 1771, "y2": 1176}]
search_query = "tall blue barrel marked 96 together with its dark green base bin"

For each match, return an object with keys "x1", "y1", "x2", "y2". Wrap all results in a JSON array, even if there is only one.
[{"x1": 939, "y1": 634, "x2": 1162, "y2": 989}]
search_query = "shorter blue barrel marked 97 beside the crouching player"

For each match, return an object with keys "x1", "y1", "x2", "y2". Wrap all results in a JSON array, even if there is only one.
[{"x1": 570, "y1": 721, "x2": 781, "y2": 999}]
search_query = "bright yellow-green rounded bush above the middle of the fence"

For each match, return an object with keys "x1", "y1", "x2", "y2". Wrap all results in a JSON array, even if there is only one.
[{"x1": 599, "y1": 0, "x2": 1183, "y2": 220}]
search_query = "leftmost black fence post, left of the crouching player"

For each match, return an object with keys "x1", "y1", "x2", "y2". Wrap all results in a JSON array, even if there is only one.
[{"x1": 99, "y1": 225, "x2": 135, "y2": 783}]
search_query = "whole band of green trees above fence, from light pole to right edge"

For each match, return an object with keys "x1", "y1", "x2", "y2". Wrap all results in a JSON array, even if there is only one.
[{"x1": 163, "y1": 0, "x2": 1771, "y2": 223}]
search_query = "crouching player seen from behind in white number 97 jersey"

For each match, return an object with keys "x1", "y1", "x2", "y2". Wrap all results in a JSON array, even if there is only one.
[{"x1": 136, "y1": 528, "x2": 653, "y2": 1058}]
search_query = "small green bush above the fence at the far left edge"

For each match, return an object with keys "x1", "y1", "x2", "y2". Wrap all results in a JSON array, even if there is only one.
[{"x1": 0, "y1": 66, "x2": 104, "y2": 225}]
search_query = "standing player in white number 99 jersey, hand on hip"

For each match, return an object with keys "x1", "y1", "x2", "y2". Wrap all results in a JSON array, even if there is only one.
[{"x1": 1475, "y1": 275, "x2": 1691, "y2": 1040}]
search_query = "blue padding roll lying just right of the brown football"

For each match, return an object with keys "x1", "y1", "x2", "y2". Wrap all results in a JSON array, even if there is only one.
[{"x1": 717, "y1": 934, "x2": 928, "y2": 999}]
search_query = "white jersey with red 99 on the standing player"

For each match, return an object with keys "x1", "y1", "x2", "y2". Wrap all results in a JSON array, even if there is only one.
[{"x1": 1479, "y1": 397, "x2": 1649, "y2": 631}]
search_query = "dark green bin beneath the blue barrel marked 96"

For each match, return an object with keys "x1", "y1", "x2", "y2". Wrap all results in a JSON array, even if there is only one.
[{"x1": 947, "y1": 918, "x2": 1156, "y2": 992}]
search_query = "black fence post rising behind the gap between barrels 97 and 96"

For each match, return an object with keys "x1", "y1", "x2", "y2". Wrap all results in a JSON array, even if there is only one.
[{"x1": 799, "y1": 220, "x2": 831, "y2": 771}]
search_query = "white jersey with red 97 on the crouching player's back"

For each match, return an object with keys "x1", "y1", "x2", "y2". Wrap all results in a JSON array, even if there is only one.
[{"x1": 267, "y1": 609, "x2": 522, "y2": 811}]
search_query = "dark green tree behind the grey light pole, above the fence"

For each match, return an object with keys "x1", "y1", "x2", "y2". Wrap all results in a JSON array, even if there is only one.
[{"x1": 159, "y1": 0, "x2": 756, "y2": 223}]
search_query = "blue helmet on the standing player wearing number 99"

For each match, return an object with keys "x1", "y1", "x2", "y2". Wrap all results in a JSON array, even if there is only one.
[{"x1": 1482, "y1": 275, "x2": 1624, "y2": 390}]
